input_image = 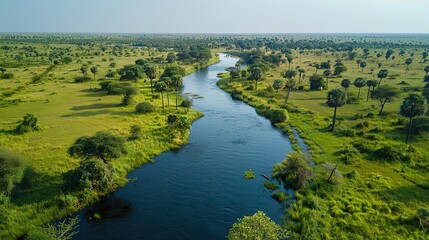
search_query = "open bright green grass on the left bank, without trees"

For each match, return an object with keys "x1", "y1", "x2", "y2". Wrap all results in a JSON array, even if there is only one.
[{"x1": 0, "y1": 43, "x2": 218, "y2": 239}]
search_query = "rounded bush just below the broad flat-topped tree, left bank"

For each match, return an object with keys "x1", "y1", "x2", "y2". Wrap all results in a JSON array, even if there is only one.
[{"x1": 63, "y1": 159, "x2": 113, "y2": 192}]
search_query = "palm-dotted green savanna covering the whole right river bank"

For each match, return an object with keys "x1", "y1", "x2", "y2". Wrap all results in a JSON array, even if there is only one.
[{"x1": 218, "y1": 36, "x2": 429, "y2": 239}]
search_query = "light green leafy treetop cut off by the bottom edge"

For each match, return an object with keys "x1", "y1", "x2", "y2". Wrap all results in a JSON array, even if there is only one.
[{"x1": 227, "y1": 211, "x2": 287, "y2": 240}]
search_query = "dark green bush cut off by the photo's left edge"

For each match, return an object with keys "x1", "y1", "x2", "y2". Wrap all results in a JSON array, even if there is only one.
[{"x1": 0, "y1": 148, "x2": 26, "y2": 196}]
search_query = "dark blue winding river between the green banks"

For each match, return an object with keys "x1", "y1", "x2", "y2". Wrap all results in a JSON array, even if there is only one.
[{"x1": 76, "y1": 54, "x2": 291, "y2": 240}]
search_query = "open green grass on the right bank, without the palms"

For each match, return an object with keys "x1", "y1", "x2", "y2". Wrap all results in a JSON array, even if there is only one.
[{"x1": 218, "y1": 49, "x2": 429, "y2": 239}]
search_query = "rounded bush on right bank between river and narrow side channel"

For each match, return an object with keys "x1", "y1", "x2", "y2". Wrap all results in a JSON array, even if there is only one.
[{"x1": 273, "y1": 152, "x2": 311, "y2": 189}]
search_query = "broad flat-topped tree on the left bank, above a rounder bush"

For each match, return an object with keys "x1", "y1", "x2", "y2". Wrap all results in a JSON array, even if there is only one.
[{"x1": 68, "y1": 132, "x2": 126, "y2": 164}]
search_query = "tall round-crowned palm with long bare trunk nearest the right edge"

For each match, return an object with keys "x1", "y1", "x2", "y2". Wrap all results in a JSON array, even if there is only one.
[{"x1": 401, "y1": 93, "x2": 426, "y2": 144}]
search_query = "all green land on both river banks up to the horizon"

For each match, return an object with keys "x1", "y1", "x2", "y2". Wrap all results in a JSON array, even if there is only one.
[{"x1": 0, "y1": 33, "x2": 429, "y2": 240}]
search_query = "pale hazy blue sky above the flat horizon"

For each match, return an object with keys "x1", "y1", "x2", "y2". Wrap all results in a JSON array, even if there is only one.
[{"x1": 0, "y1": 0, "x2": 429, "y2": 33}]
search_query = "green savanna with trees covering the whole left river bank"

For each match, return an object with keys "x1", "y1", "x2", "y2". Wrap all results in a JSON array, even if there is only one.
[{"x1": 0, "y1": 35, "x2": 218, "y2": 239}]
